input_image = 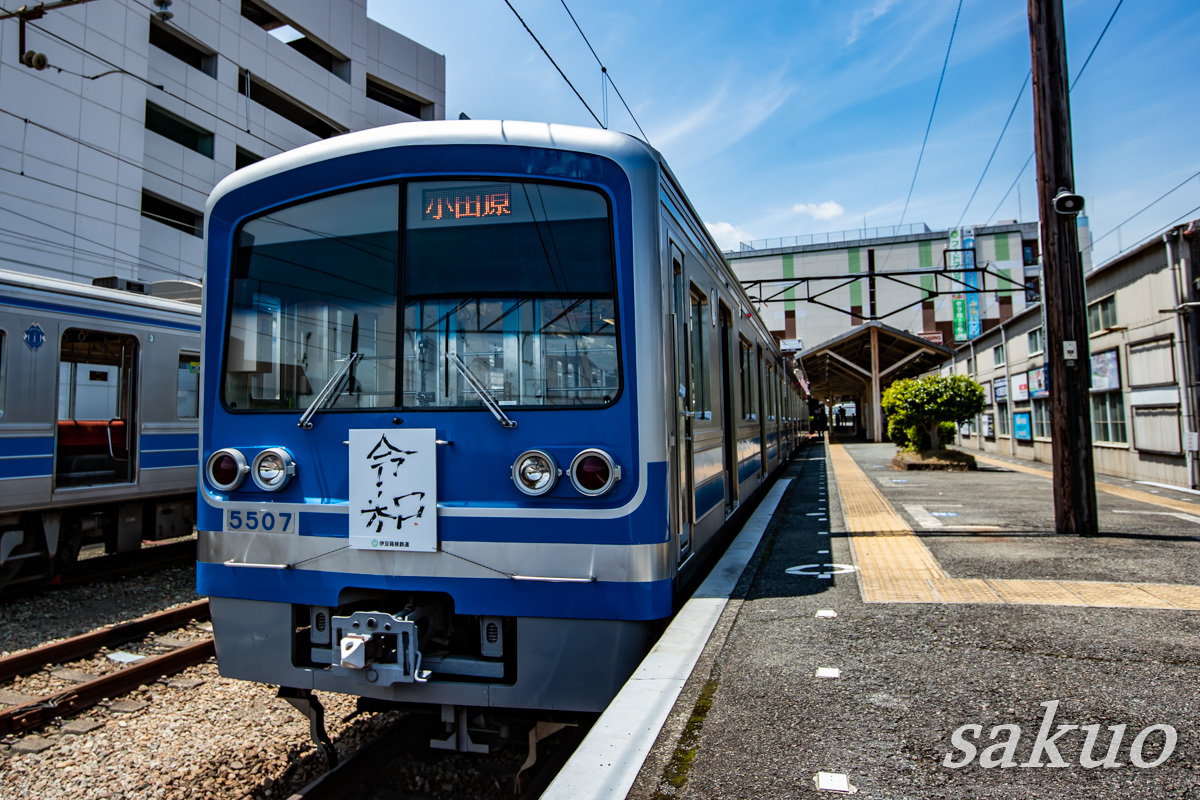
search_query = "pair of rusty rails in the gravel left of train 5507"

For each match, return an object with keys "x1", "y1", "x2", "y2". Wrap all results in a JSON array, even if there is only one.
[{"x1": 0, "y1": 601, "x2": 215, "y2": 735}]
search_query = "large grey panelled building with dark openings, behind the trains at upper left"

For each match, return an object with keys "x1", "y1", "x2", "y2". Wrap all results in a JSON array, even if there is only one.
[{"x1": 0, "y1": 0, "x2": 445, "y2": 282}]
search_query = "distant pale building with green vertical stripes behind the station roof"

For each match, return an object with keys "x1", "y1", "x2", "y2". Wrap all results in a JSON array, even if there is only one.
[{"x1": 725, "y1": 222, "x2": 1038, "y2": 349}]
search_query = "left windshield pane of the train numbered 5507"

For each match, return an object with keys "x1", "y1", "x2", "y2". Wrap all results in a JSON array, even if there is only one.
[{"x1": 224, "y1": 185, "x2": 400, "y2": 410}]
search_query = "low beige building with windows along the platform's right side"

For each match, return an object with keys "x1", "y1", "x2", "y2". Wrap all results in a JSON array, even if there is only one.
[{"x1": 942, "y1": 221, "x2": 1200, "y2": 488}]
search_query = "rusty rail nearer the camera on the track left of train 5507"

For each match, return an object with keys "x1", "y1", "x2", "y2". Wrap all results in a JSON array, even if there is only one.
[{"x1": 0, "y1": 639, "x2": 216, "y2": 735}]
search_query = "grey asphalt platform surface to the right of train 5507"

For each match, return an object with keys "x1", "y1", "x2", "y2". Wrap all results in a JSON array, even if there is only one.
[{"x1": 630, "y1": 445, "x2": 1200, "y2": 800}]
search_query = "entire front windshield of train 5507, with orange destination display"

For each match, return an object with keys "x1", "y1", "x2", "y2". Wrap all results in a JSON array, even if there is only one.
[{"x1": 223, "y1": 180, "x2": 620, "y2": 410}]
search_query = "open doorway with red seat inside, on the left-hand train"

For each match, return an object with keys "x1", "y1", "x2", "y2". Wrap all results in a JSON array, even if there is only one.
[{"x1": 54, "y1": 327, "x2": 138, "y2": 489}]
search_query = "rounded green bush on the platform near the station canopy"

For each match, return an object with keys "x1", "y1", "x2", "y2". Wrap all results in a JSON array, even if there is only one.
[{"x1": 882, "y1": 375, "x2": 983, "y2": 450}]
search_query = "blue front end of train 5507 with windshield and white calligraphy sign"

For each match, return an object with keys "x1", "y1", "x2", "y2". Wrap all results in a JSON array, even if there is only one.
[{"x1": 197, "y1": 124, "x2": 673, "y2": 711}]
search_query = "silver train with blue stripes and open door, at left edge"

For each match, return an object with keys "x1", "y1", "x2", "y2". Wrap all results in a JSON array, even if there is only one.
[{"x1": 0, "y1": 270, "x2": 200, "y2": 589}]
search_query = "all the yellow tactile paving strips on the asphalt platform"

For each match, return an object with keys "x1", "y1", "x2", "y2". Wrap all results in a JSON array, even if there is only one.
[{"x1": 829, "y1": 441, "x2": 1200, "y2": 610}]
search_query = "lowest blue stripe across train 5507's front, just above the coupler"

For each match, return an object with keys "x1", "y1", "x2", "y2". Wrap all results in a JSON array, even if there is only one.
[{"x1": 196, "y1": 561, "x2": 672, "y2": 620}]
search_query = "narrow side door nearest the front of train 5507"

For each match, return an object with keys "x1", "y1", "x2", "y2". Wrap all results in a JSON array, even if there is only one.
[{"x1": 671, "y1": 243, "x2": 694, "y2": 564}]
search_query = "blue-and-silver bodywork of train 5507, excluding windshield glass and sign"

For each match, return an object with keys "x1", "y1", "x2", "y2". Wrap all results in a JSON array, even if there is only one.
[{"x1": 198, "y1": 121, "x2": 806, "y2": 711}]
